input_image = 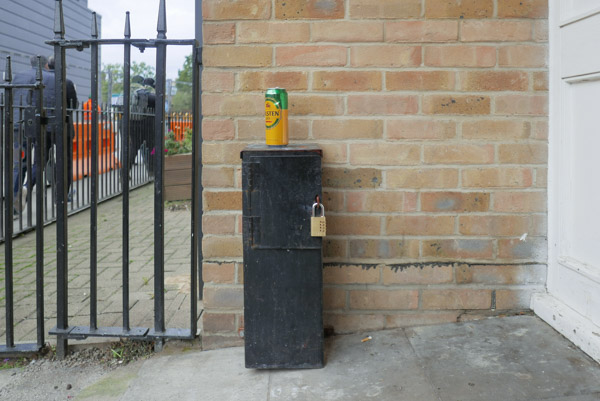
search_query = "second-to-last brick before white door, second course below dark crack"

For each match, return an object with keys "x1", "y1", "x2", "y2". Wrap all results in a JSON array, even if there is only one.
[{"x1": 422, "y1": 290, "x2": 492, "y2": 310}]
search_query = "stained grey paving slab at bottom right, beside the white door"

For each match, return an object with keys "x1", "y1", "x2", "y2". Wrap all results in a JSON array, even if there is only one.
[{"x1": 407, "y1": 316, "x2": 600, "y2": 401}]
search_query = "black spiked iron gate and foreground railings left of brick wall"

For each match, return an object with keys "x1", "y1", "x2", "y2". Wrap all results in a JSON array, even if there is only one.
[{"x1": 0, "y1": 0, "x2": 203, "y2": 357}]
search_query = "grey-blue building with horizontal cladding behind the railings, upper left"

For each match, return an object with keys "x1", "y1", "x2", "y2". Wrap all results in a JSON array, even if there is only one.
[{"x1": 0, "y1": 0, "x2": 100, "y2": 102}]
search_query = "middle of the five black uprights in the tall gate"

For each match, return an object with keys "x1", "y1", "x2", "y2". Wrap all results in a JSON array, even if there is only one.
[{"x1": 121, "y1": 11, "x2": 131, "y2": 331}]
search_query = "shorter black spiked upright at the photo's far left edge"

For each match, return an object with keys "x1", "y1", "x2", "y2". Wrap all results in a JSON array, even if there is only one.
[{"x1": 4, "y1": 56, "x2": 15, "y2": 348}]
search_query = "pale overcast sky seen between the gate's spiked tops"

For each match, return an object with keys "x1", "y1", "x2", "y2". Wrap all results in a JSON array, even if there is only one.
[{"x1": 88, "y1": 0, "x2": 194, "y2": 79}]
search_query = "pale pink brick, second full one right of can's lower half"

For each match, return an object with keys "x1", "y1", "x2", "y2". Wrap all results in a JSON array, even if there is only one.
[{"x1": 386, "y1": 120, "x2": 456, "y2": 140}]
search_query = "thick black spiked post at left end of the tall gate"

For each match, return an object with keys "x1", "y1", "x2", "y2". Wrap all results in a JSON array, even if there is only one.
[{"x1": 54, "y1": 0, "x2": 70, "y2": 358}]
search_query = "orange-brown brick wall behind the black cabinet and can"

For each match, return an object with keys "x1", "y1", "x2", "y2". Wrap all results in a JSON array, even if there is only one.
[{"x1": 203, "y1": 0, "x2": 548, "y2": 348}]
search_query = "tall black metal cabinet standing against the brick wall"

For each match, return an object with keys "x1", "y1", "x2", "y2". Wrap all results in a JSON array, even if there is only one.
[{"x1": 242, "y1": 145, "x2": 324, "y2": 369}]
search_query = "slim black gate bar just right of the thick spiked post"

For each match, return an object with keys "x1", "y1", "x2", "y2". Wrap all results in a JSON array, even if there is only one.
[{"x1": 90, "y1": 12, "x2": 98, "y2": 330}]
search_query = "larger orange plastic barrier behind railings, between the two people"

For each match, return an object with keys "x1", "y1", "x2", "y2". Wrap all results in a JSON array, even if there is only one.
[{"x1": 73, "y1": 122, "x2": 121, "y2": 181}]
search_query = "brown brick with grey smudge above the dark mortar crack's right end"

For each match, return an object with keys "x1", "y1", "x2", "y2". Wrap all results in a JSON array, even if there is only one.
[{"x1": 422, "y1": 239, "x2": 494, "y2": 259}]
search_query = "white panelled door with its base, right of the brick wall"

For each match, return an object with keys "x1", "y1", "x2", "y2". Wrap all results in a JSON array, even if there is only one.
[{"x1": 532, "y1": 0, "x2": 600, "y2": 360}]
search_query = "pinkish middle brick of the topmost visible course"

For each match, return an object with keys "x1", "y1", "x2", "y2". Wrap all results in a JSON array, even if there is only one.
[{"x1": 349, "y1": 0, "x2": 421, "y2": 19}]
